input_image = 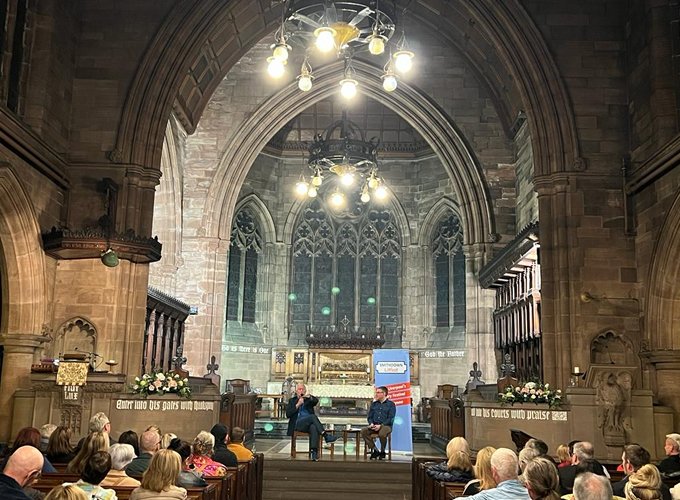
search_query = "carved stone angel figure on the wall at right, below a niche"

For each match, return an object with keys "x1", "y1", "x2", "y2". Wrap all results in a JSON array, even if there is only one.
[{"x1": 594, "y1": 372, "x2": 632, "y2": 446}]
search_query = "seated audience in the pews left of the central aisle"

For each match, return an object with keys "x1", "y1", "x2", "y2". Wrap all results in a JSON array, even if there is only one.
[{"x1": 0, "y1": 414, "x2": 253, "y2": 500}]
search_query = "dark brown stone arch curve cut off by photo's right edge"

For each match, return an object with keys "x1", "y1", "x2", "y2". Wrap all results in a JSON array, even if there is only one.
[{"x1": 646, "y1": 189, "x2": 680, "y2": 350}]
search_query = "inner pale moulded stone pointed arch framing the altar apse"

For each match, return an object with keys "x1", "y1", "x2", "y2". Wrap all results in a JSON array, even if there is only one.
[{"x1": 202, "y1": 61, "x2": 494, "y2": 252}]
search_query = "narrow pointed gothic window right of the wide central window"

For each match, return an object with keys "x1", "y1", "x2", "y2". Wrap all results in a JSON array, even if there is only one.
[{"x1": 432, "y1": 212, "x2": 465, "y2": 327}]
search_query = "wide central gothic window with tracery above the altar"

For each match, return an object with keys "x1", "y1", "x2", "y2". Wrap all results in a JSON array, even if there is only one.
[{"x1": 290, "y1": 200, "x2": 401, "y2": 328}]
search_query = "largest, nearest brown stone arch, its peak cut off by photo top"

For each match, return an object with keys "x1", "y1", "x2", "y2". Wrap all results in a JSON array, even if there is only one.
[{"x1": 112, "y1": 0, "x2": 583, "y2": 182}]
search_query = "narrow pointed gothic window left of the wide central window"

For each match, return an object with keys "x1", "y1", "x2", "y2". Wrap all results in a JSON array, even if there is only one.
[{"x1": 227, "y1": 208, "x2": 262, "y2": 323}]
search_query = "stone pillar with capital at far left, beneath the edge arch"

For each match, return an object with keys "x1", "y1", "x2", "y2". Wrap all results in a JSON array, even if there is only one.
[{"x1": 0, "y1": 333, "x2": 50, "y2": 443}]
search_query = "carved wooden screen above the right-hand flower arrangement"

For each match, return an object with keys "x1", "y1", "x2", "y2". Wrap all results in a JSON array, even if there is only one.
[{"x1": 493, "y1": 263, "x2": 543, "y2": 381}]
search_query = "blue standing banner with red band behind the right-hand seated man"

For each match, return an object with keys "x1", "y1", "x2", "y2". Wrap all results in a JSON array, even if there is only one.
[{"x1": 373, "y1": 349, "x2": 413, "y2": 454}]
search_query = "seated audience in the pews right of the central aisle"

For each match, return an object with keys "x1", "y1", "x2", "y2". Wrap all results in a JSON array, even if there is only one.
[{"x1": 427, "y1": 434, "x2": 680, "y2": 500}]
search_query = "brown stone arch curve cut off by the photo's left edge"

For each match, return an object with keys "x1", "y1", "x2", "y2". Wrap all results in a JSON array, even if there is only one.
[{"x1": 0, "y1": 164, "x2": 47, "y2": 335}]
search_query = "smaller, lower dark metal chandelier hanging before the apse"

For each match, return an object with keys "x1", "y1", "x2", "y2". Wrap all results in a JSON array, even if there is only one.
[{"x1": 295, "y1": 112, "x2": 387, "y2": 209}]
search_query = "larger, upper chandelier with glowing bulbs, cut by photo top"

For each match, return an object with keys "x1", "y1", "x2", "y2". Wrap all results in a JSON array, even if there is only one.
[{"x1": 267, "y1": 0, "x2": 414, "y2": 94}]
